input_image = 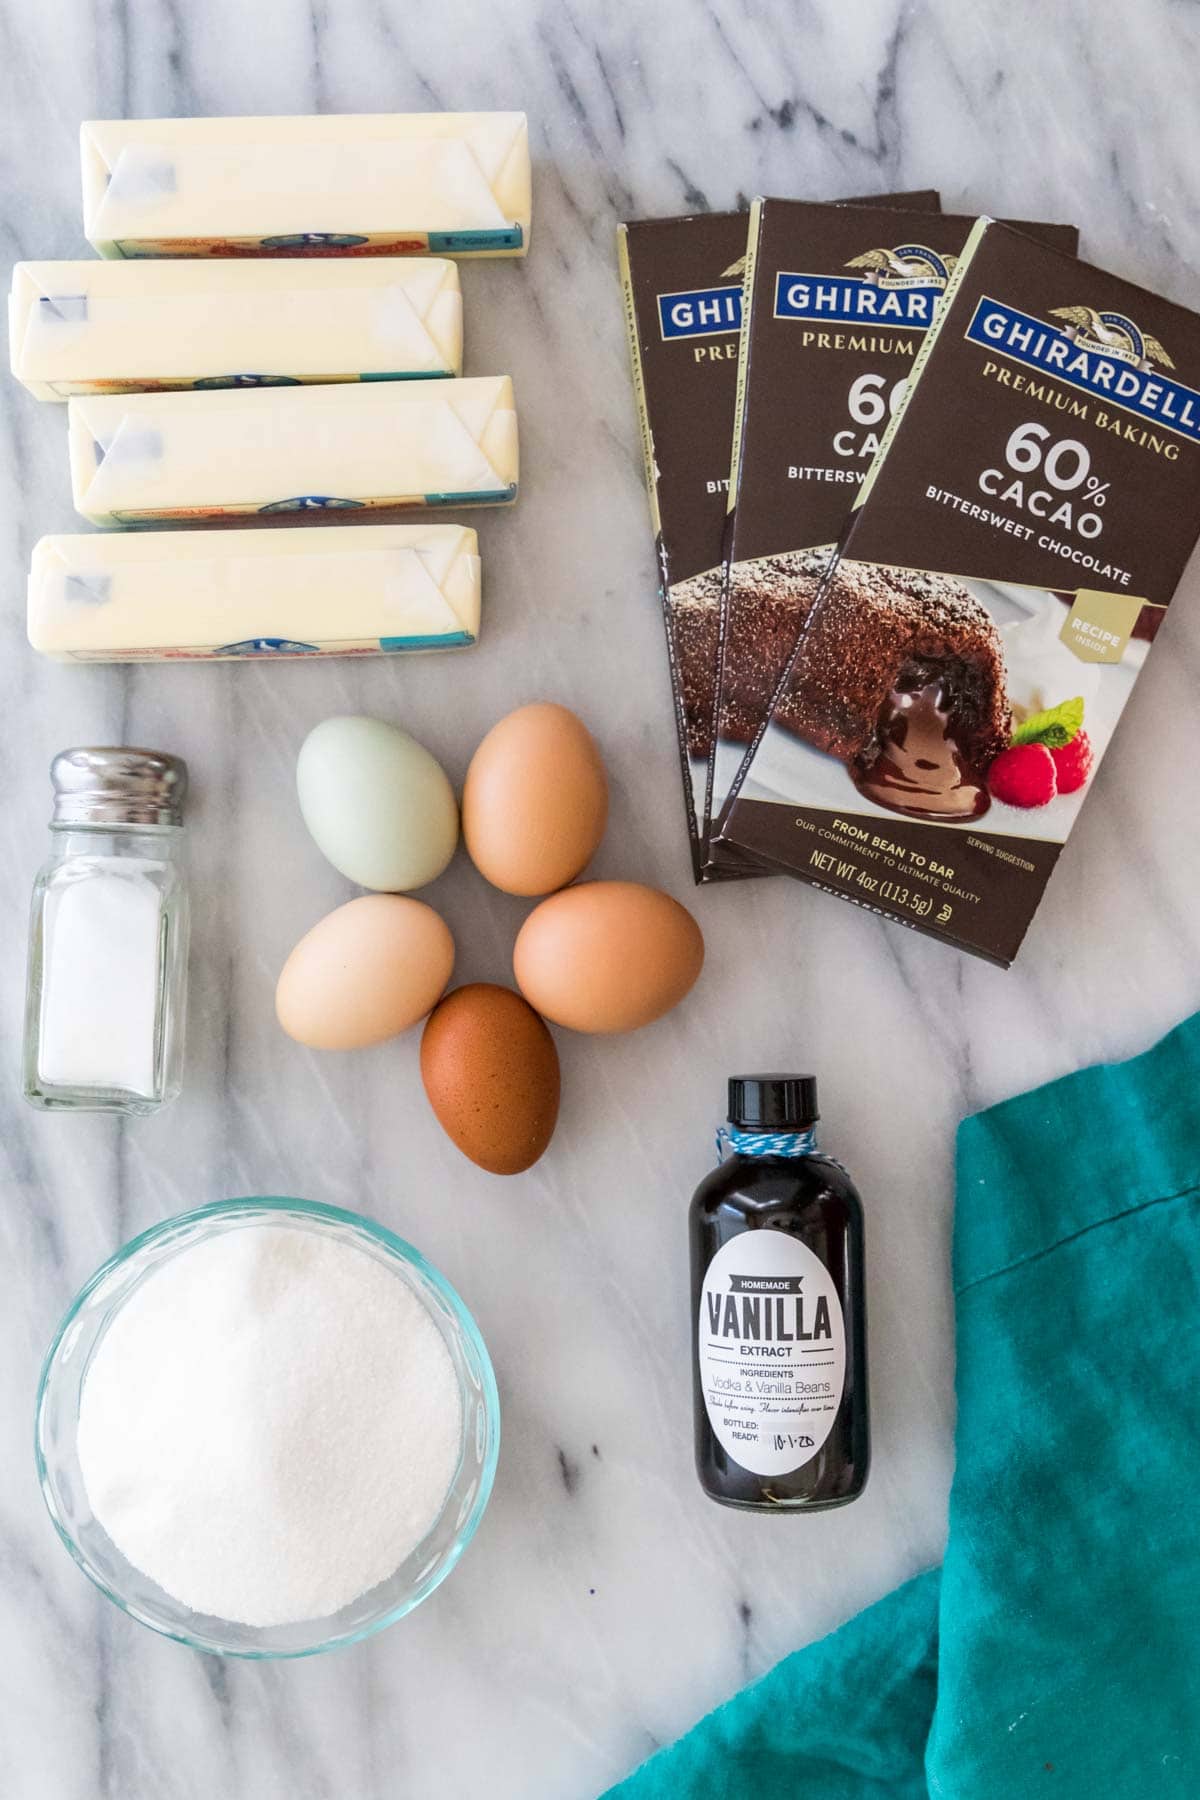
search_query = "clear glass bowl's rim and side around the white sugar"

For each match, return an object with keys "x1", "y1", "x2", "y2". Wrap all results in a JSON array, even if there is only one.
[{"x1": 34, "y1": 1199, "x2": 500, "y2": 1658}]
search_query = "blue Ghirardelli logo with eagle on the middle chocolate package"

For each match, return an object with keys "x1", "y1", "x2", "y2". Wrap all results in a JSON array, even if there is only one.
[{"x1": 775, "y1": 243, "x2": 957, "y2": 331}]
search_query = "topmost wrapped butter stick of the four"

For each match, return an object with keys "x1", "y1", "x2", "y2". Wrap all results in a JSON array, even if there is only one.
[{"x1": 81, "y1": 113, "x2": 531, "y2": 256}]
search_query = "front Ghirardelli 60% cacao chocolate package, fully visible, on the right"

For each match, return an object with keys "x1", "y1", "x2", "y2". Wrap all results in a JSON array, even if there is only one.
[{"x1": 725, "y1": 220, "x2": 1200, "y2": 965}]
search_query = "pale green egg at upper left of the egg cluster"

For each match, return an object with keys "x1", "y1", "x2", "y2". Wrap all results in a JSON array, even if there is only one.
[{"x1": 295, "y1": 718, "x2": 459, "y2": 893}]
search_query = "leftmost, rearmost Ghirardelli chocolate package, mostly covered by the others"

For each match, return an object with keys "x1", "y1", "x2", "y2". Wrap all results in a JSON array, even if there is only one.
[{"x1": 617, "y1": 191, "x2": 939, "y2": 878}]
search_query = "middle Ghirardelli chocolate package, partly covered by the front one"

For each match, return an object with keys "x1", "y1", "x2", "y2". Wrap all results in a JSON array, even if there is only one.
[{"x1": 707, "y1": 200, "x2": 1078, "y2": 869}]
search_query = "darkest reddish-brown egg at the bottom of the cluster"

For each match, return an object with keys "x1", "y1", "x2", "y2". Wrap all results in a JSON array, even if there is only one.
[{"x1": 421, "y1": 981, "x2": 560, "y2": 1175}]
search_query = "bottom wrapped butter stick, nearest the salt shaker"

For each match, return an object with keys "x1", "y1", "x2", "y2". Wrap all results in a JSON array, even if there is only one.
[{"x1": 29, "y1": 524, "x2": 480, "y2": 662}]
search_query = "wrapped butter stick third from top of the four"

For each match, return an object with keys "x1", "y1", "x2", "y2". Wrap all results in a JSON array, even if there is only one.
[{"x1": 67, "y1": 374, "x2": 518, "y2": 526}]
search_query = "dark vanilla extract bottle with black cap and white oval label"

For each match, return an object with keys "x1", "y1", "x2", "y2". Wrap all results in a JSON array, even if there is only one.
[{"x1": 691, "y1": 1075, "x2": 871, "y2": 1512}]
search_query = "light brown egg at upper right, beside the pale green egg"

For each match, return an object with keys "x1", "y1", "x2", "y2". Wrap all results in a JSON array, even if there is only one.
[{"x1": 462, "y1": 702, "x2": 608, "y2": 895}]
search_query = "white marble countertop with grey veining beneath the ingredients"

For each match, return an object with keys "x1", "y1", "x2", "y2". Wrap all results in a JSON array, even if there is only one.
[{"x1": 0, "y1": 0, "x2": 1200, "y2": 1800}]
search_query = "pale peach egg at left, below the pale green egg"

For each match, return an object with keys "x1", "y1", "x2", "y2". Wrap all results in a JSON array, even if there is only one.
[{"x1": 275, "y1": 895, "x2": 453, "y2": 1049}]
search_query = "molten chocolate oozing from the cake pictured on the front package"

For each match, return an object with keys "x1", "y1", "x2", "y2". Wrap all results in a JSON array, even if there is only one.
[{"x1": 851, "y1": 664, "x2": 990, "y2": 823}]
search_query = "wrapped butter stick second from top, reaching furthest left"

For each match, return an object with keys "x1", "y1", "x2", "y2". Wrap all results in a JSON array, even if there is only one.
[{"x1": 9, "y1": 256, "x2": 462, "y2": 400}]
